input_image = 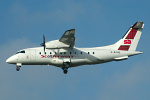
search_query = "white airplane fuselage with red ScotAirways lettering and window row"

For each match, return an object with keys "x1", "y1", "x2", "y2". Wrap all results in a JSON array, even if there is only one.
[{"x1": 6, "y1": 47, "x2": 141, "y2": 67}]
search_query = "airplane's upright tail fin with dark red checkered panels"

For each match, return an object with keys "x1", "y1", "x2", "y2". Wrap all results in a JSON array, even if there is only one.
[{"x1": 111, "y1": 21, "x2": 144, "y2": 53}]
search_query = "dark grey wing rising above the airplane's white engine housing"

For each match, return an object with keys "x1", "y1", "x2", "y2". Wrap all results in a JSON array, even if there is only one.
[{"x1": 59, "y1": 29, "x2": 75, "y2": 48}]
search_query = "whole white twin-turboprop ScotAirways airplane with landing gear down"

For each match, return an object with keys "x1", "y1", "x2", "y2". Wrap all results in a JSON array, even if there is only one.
[{"x1": 6, "y1": 21, "x2": 144, "y2": 74}]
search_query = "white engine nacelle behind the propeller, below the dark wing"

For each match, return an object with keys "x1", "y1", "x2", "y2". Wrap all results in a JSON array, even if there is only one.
[{"x1": 45, "y1": 40, "x2": 69, "y2": 49}]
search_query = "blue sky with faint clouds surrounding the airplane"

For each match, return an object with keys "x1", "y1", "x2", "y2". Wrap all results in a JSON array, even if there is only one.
[{"x1": 0, "y1": 0, "x2": 150, "y2": 100}]
